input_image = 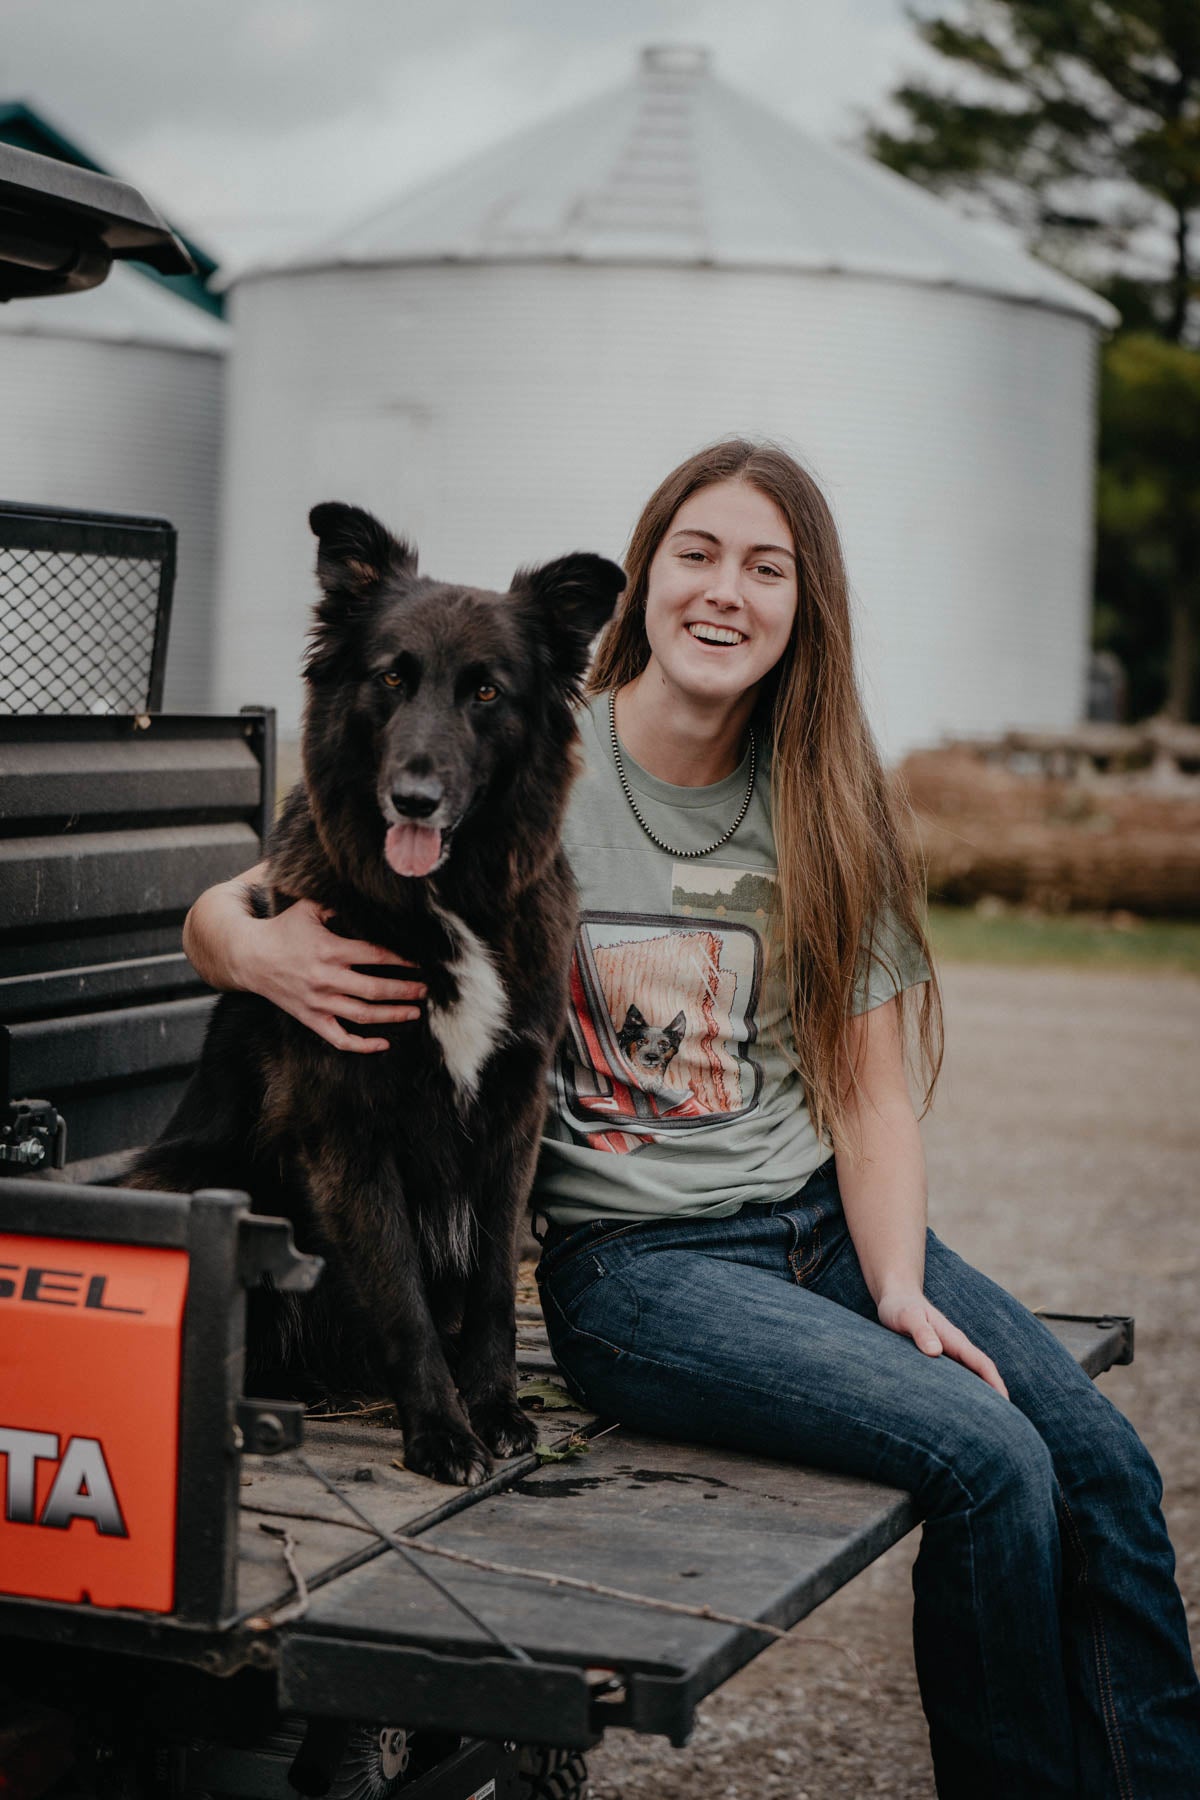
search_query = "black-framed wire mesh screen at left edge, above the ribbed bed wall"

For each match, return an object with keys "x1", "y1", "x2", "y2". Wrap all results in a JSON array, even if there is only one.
[{"x1": 0, "y1": 506, "x2": 175, "y2": 713}]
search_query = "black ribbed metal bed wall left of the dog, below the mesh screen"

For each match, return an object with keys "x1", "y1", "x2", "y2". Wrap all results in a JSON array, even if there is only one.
[{"x1": 0, "y1": 707, "x2": 275, "y2": 1181}]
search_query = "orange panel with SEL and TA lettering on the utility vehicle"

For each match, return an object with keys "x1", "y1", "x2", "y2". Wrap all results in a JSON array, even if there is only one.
[{"x1": 0, "y1": 1233, "x2": 187, "y2": 1613}]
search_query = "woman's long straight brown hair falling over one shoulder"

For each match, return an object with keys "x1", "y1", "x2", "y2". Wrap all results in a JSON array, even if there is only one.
[{"x1": 588, "y1": 437, "x2": 943, "y2": 1141}]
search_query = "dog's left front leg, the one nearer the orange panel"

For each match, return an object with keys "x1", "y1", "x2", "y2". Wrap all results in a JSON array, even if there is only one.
[{"x1": 308, "y1": 1154, "x2": 491, "y2": 1487}]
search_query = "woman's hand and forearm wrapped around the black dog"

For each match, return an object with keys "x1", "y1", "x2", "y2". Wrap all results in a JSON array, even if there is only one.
[{"x1": 184, "y1": 862, "x2": 425, "y2": 1051}]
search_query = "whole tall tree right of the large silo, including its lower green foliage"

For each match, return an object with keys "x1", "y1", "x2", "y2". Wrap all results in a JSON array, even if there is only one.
[{"x1": 865, "y1": 0, "x2": 1200, "y2": 718}]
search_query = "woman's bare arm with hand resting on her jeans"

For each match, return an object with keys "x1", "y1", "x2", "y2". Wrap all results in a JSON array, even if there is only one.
[{"x1": 835, "y1": 1001, "x2": 1007, "y2": 1397}]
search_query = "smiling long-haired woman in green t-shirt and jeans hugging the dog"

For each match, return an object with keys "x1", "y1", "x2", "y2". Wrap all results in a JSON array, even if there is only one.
[{"x1": 187, "y1": 441, "x2": 1200, "y2": 1800}]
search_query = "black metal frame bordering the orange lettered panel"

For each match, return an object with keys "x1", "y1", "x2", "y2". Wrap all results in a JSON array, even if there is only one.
[{"x1": 0, "y1": 1179, "x2": 320, "y2": 1645}]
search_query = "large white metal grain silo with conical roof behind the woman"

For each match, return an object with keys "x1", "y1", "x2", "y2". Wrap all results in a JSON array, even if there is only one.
[{"x1": 218, "y1": 49, "x2": 1115, "y2": 754}]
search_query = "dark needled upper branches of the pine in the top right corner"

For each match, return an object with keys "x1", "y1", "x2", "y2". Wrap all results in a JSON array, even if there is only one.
[{"x1": 865, "y1": 0, "x2": 1200, "y2": 342}]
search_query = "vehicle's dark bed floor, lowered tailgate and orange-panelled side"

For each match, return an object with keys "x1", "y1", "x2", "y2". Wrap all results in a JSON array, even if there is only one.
[{"x1": 0, "y1": 1179, "x2": 1133, "y2": 1748}]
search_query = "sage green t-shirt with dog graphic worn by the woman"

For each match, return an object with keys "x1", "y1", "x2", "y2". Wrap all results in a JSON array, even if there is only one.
[{"x1": 534, "y1": 697, "x2": 928, "y2": 1224}]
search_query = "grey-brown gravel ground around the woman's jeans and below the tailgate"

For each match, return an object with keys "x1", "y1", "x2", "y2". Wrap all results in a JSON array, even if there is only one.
[{"x1": 588, "y1": 967, "x2": 1200, "y2": 1800}]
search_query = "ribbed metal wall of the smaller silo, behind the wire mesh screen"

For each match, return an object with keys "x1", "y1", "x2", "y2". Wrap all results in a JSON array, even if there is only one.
[{"x1": 0, "y1": 331, "x2": 223, "y2": 711}]
